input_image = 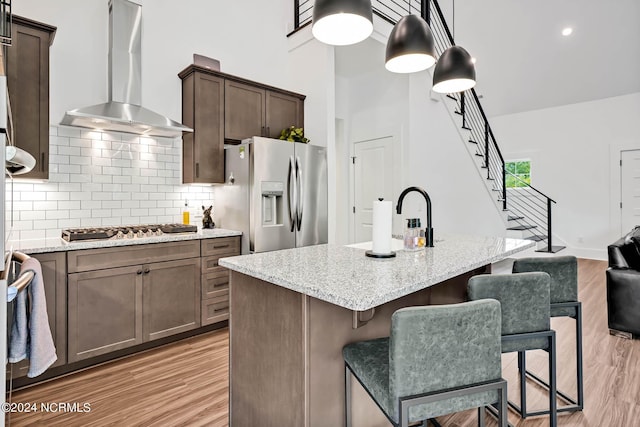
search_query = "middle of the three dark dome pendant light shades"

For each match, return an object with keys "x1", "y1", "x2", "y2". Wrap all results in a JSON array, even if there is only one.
[{"x1": 385, "y1": 15, "x2": 436, "y2": 73}]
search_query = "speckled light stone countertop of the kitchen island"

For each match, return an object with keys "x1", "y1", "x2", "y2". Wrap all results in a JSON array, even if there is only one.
[{"x1": 218, "y1": 233, "x2": 535, "y2": 311}]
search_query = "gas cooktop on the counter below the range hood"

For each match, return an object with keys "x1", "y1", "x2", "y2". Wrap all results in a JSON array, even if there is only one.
[{"x1": 62, "y1": 224, "x2": 198, "y2": 242}]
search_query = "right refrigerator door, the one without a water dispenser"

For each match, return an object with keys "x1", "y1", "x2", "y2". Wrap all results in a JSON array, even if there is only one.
[{"x1": 295, "y1": 143, "x2": 329, "y2": 247}]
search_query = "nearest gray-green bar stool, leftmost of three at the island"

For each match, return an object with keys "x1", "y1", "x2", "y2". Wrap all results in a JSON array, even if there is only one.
[{"x1": 342, "y1": 300, "x2": 507, "y2": 427}]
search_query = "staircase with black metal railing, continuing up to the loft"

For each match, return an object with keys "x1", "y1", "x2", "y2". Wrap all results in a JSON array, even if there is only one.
[{"x1": 291, "y1": 0, "x2": 565, "y2": 253}]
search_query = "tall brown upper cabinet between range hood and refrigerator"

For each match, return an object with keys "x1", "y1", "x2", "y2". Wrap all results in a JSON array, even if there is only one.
[{"x1": 180, "y1": 69, "x2": 225, "y2": 184}]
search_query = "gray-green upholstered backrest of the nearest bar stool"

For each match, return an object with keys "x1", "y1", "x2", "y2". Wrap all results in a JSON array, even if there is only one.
[{"x1": 389, "y1": 300, "x2": 502, "y2": 419}]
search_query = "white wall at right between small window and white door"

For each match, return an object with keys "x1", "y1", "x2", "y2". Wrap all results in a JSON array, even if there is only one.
[{"x1": 490, "y1": 93, "x2": 640, "y2": 259}]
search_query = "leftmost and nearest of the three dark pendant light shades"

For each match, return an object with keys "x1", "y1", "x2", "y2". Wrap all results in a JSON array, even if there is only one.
[{"x1": 311, "y1": 0, "x2": 373, "y2": 46}]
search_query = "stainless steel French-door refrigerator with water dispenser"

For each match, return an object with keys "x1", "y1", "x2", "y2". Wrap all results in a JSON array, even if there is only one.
[{"x1": 213, "y1": 137, "x2": 328, "y2": 254}]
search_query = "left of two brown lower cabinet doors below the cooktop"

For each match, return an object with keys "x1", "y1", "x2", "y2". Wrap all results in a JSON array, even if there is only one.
[{"x1": 67, "y1": 265, "x2": 143, "y2": 362}]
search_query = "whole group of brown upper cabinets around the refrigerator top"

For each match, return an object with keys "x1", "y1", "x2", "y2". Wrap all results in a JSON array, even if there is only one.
[{"x1": 178, "y1": 65, "x2": 305, "y2": 184}]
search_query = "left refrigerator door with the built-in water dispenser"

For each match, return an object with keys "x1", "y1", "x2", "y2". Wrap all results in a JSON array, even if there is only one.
[{"x1": 249, "y1": 138, "x2": 296, "y2": 252}]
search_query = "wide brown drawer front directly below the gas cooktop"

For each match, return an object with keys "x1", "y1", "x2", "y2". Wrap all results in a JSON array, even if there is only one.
[{"x1": 68, "y1": 240, "x2": 200, "y2": 273}]
